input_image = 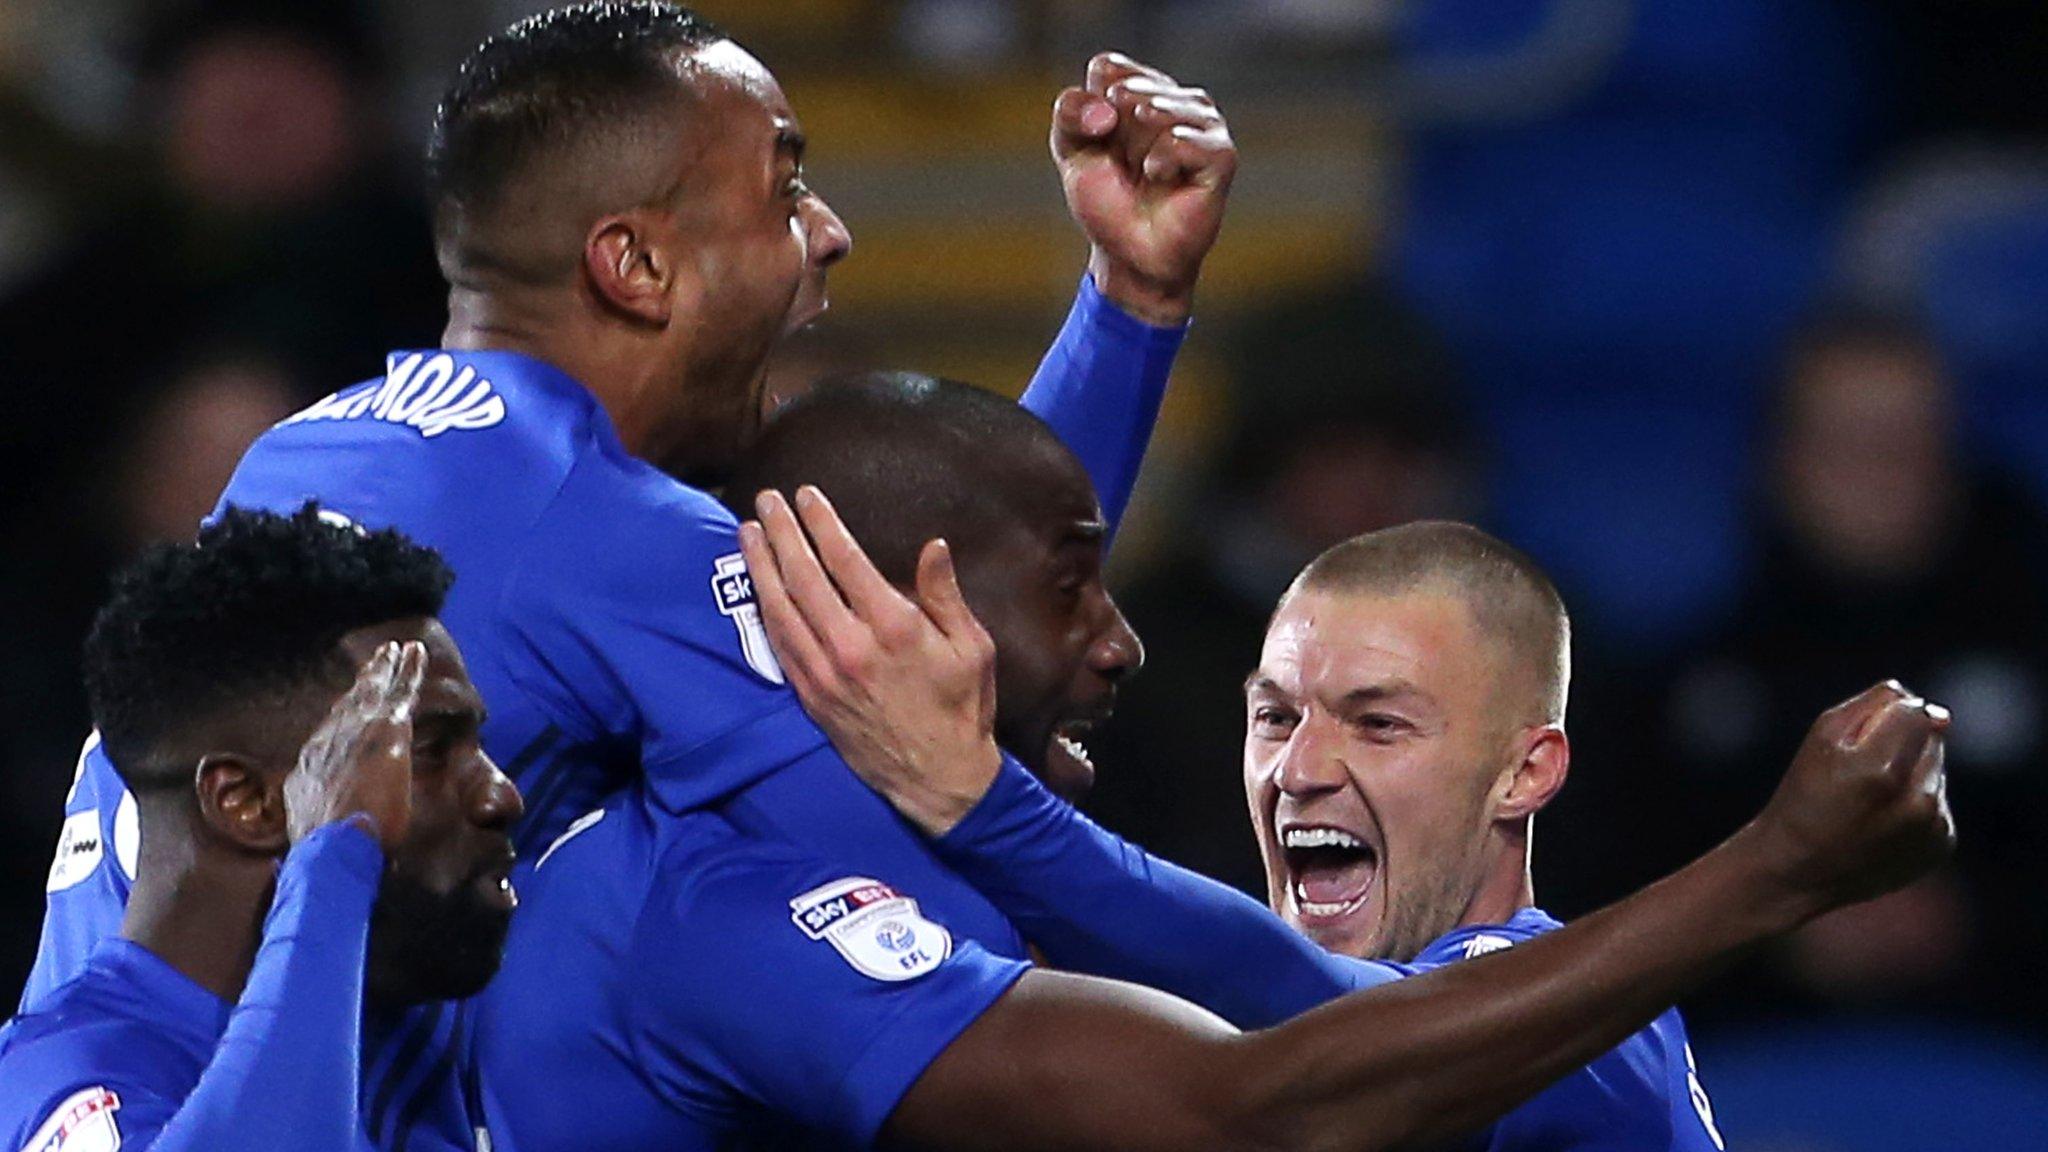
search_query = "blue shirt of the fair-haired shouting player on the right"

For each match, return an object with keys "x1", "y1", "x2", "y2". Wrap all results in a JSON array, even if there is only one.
[{"x1": 938, "y1": 763, "x2": 1720, "y2": 1152}]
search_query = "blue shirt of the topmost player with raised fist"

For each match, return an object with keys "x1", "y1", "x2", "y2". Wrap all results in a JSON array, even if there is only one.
[{"x1": 25, "y1": 279, "x2": 1182, "y2": 1123}]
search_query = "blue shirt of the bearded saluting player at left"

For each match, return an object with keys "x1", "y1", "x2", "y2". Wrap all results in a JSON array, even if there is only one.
[{"x1": 0, "y1": 824, "x2": 387, "y2": 1152}]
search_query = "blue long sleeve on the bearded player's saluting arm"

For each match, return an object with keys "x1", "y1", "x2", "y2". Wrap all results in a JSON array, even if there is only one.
[{"x1": 137, "y1": 824, "x2": 383, "y2": 1152}]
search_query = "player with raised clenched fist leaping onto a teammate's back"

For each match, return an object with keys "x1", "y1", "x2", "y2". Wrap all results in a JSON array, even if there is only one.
[{"x1": 25, "y1": 0, "x2": 1235, "y2": 1150}]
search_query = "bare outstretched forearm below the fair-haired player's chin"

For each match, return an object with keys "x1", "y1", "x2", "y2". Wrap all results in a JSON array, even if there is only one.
[{"x1": 1241, "y1": 824, "x2": 1815, "y2": 1148}]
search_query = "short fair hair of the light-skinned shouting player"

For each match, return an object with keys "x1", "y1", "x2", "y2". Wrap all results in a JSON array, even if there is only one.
[{"x1": 1280, "y1": 521, "x2": 1571, "y2": 724}]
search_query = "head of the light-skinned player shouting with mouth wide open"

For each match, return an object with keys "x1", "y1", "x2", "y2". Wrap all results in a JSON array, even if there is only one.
[{"x1": 1245, "y1": 523, "x2": 1571, "y2": 959}]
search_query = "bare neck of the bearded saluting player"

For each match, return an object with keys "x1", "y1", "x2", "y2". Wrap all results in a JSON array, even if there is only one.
[{"x1": 121, "y1": 836, "x2": 276, "y2": 1000}]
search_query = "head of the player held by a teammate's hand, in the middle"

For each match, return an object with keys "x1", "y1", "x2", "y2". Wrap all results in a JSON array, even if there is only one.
[{"x1": 727, "y1": 373, "x2": 1145, "y2": 799}]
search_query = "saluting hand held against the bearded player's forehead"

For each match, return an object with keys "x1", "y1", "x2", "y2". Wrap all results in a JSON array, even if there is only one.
[{"x1": 285, "y1": 640, "x2": 426, "y2": 851}]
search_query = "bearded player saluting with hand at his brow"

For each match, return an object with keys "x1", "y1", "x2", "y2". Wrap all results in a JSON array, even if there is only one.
[{"x1": 0, "y1": 508, "x2": 520, "y2": 1152}]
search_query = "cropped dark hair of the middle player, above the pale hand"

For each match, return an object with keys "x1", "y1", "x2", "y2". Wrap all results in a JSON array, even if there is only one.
[{"x1": 725, "y1": 371, "x2": 1085, "y2": 584}]
